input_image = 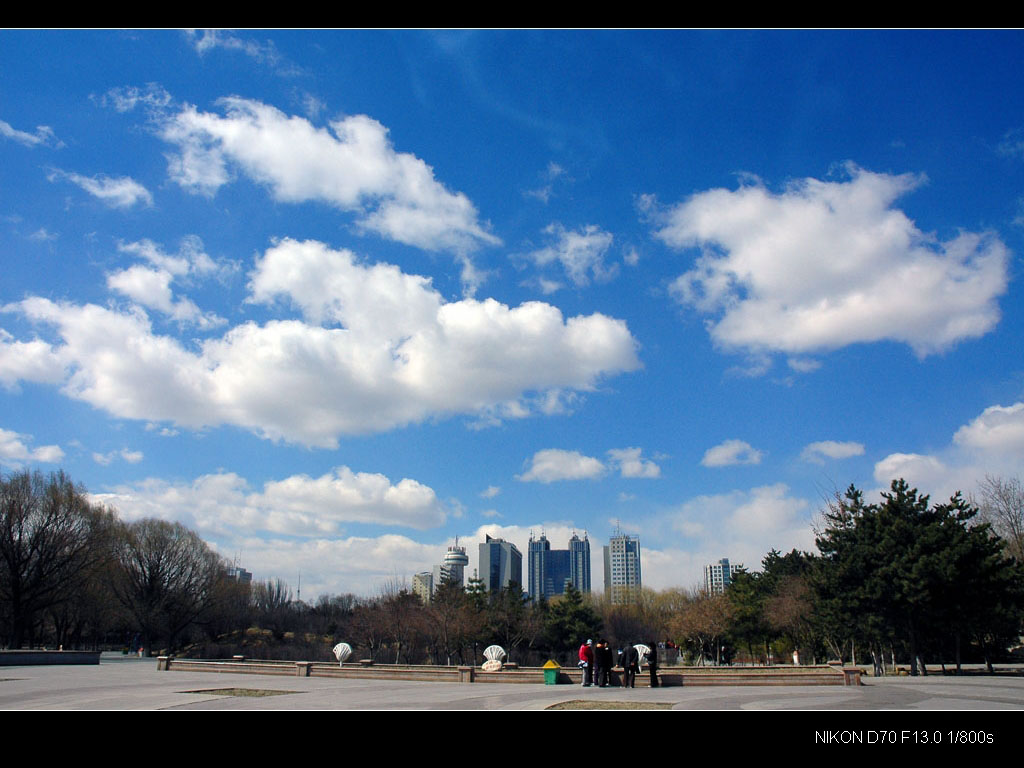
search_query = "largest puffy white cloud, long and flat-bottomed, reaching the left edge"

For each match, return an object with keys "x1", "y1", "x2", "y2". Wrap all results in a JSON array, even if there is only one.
[{"x1": 0, "y1": 241, "x2": 640, "y2": 446}]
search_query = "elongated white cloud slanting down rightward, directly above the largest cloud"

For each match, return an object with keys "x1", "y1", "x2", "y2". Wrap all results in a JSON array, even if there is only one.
[{"x1": 161, "y1": 97, "x2": 501, "y2": 254}]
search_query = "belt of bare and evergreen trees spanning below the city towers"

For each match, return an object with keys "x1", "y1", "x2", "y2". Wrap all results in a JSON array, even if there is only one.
[{"x1": 0, "y1": 471, "x2": 1024, "y2": 674}]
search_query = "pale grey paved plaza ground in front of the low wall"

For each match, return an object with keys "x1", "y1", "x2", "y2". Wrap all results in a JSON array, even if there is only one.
[{"x1": 0, "y1": 656, "x2": 1024, "y2": 716}]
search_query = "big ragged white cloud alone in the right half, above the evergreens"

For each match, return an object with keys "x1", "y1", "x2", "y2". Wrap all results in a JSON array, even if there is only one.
[{"x1": 656, "y1": 164, "x2": 1009, "y2": 356}]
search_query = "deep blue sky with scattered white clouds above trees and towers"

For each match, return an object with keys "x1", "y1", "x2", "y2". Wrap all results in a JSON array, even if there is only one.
[{"x1": 0, "y1": 31, "x2": 1024, "y2": 597}]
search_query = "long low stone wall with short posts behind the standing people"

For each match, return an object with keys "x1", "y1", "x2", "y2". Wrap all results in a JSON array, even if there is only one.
[{"x1": 157, "y1": 656, "x2": 860, "y2": 688}]
